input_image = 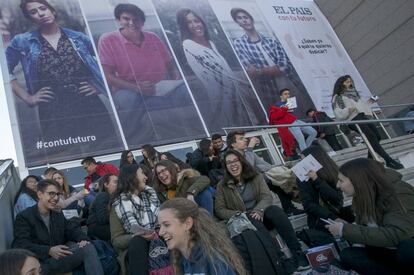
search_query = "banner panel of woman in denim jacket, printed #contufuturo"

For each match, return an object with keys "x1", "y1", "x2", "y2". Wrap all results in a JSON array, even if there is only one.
[{"x1": 3, "y1": 0, "x2": 123, "y2": 166}]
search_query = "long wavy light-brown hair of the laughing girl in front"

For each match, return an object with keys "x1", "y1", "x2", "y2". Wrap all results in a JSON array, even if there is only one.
[{"x1": 160, "y1": 198, "x2": 246, "y2": 275}]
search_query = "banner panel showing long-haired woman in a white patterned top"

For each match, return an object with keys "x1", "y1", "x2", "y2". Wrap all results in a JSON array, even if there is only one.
[{"x1": 153, "y1": 0, "x2": 266, "y2": 135}]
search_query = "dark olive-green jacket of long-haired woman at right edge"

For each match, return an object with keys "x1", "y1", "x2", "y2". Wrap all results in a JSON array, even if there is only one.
[{"x1": 342, "y1": 176, "x2": 414, "y2": 247}]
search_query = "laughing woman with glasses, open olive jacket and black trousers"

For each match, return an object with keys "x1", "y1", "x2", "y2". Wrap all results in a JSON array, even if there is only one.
[{"x1": 214, "y1": 149, "x2": 309, "y2": 271}]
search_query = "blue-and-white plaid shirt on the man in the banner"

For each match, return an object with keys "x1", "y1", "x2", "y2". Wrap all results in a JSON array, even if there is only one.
[{"x1": 233, "y1": 34, "x2": 295, "y2": 76}]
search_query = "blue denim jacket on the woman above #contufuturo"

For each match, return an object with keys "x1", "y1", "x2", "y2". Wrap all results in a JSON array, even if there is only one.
[{"x1": 6, "y1": 28, "x2": 105, "y2": 94}]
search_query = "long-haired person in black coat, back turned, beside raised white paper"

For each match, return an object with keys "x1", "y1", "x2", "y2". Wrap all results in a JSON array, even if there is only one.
[{"x1": 298, "y1": 145, "x2": 354, "y2": 232}]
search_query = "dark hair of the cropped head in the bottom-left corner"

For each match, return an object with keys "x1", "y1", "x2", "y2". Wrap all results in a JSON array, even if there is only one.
[{"x1": 0, "y1": 249, "x2": 37, "y2": 275}]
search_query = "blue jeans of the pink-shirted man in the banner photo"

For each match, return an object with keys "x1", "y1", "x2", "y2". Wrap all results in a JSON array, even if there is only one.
[{"x1": 113, "y1": 85, "x2": 196, "y2": 147}]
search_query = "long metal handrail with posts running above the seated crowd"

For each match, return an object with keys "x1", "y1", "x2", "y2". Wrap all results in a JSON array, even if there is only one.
[{"x1": 223, "y1": 117, "x2": 414, "y2": 164}]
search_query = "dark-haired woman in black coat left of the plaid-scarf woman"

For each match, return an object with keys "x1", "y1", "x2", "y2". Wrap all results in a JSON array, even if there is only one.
[{"x1": 86, "y1": 174, "x2": 118, "y2": 242}]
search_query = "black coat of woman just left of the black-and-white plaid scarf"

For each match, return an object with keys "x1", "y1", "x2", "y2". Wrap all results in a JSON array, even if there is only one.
[{"x1": 87, "y1": 192, "x2": 110, "y2": 226}]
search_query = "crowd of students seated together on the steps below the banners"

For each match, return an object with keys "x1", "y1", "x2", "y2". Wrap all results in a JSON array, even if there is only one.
[{"x1": 5, "y1": 132, "x2": 414, "y2": 275}]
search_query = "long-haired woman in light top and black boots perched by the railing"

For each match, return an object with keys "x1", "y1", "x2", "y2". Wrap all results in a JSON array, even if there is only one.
[{"x1": 332, "y1": 75, "x2": 404, "y2": 169}]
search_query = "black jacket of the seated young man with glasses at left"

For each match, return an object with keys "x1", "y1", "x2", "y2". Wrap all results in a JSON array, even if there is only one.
[{"x1": 12, "y1": 204, "x2": 88, "y2": 261}]
